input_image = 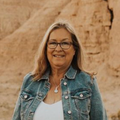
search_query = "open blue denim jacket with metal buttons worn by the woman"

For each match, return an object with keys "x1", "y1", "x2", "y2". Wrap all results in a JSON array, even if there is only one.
[{"x1": 12, "y1": 67, "x2": 107, "y2": 120}]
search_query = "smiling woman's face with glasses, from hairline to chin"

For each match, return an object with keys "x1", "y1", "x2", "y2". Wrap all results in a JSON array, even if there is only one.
[{"x1": 47, "y1": 28, "x2": 75, "y2": 68}]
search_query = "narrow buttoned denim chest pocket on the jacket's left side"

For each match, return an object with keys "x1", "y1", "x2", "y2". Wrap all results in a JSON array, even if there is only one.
[{"x1": 20, "y1": 91, "x2": 34, "y2": 117}]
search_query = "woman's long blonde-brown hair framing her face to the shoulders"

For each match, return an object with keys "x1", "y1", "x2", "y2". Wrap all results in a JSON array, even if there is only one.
[{"x1": 32, "y1": 21, "x2": 91, "y2": 80}]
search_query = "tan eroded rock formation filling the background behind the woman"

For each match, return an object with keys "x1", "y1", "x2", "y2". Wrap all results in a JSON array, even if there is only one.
[{"x1": 0, "y1": 0, "x2": 120, "y2": 120}]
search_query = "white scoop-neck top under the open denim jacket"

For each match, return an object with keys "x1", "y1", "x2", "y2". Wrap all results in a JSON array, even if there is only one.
[{"x1": 33, "y1": 100, "x2": 64, "y2": 120}]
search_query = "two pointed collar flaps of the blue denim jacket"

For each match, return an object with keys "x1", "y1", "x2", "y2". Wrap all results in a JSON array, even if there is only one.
[{"x1": 38, "y1": 66, "x2": 77, "y2": 81}]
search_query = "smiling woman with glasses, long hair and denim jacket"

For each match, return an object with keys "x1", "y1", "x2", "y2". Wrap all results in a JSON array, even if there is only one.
[{"x1": 13, "y1": 22, "x2": 107, "y2": 120}]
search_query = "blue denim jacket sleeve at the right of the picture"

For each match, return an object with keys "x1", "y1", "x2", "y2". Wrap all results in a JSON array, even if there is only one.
[{"x1": 90, "y1": 78, "x2": 107, "y2": 120}]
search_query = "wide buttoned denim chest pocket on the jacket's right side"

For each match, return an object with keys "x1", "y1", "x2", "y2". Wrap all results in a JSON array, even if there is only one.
[{"x1": 71, "y1": 88, "x2": 91, "y2": 115}]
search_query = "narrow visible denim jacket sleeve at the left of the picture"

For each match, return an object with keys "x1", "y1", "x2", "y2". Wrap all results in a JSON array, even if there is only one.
[{"x1": 12, "y1": 73, "x2": 31, "y2": 120}]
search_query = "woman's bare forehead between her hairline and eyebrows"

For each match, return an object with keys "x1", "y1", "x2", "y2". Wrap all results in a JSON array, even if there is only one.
[{"x1": 49, "y1": 28, "x2": 71, "y2": 39}]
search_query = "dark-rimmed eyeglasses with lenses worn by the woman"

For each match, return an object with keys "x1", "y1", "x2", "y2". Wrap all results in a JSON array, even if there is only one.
[{"x1": 47, "y1": 42, "x2": 73, "y2": 50}]
